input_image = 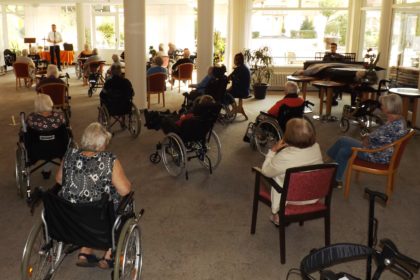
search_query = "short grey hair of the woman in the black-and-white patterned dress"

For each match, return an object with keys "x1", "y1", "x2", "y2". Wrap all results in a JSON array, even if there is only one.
[{"x1": 81, "y1": 122, "x2": 112, "y2": 152}]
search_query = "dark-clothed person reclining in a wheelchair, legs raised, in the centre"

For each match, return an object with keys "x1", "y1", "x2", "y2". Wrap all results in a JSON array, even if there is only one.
[{"x1": 145, "y1": 95, "x2": 221, "y2": 179}]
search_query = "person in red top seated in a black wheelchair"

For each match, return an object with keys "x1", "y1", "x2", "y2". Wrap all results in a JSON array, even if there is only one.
[{"x1": 244, "y1": 81, "x2": 313, "y2": 156}]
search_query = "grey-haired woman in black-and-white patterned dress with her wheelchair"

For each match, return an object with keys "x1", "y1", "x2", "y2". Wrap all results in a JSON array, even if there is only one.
[{"x1": 21, "y1": 123, "x2": 142, "y2": 279}]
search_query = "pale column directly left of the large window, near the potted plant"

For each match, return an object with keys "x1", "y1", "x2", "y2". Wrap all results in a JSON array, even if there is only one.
[{"x1": 226, "y1": 0, "x2": 252, "y2": 69}]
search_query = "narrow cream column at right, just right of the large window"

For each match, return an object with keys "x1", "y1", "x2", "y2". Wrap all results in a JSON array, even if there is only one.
[{"x1": 378, "y1": 4, "x2": 392, "y2": 69}]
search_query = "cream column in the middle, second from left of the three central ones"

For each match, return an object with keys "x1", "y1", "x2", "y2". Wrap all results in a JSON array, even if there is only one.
[{"x1": 197, "y1": 0, "x2": 214, "y2": 81}]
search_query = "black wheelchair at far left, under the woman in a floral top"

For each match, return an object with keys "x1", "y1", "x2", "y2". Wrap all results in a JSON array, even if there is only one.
[{"x1": 15, "y1": 112, "x2": 74, "y2": 197}]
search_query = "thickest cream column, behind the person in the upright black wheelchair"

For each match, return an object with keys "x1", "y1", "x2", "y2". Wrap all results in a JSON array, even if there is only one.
[{"x1": 124, "y1": 0, "x2": 147, "y2": 109}]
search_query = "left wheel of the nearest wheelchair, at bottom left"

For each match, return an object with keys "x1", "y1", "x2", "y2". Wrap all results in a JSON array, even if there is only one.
[{"x1": 21, "y1": 218, "x2": 58, "y2": 280}]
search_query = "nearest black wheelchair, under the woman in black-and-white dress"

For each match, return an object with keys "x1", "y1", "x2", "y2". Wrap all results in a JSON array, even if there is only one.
[{"x1": 20, "y1": 185, "x2": 144, "y2": 280}]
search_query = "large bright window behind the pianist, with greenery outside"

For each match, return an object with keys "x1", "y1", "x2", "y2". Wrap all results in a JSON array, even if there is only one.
[{"x1": 250, "y1": 0, "x2": 348, "y2": 65}]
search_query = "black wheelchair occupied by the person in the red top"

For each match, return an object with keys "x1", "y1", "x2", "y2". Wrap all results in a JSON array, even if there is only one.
[{"x1": 244, "y1": 100, "x2": 315, "y2": 156}]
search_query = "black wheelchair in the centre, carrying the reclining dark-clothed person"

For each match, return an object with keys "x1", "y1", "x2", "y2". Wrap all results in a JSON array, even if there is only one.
[{"x1": 149, "y1": 104, "x2": 222, "y2": 180}]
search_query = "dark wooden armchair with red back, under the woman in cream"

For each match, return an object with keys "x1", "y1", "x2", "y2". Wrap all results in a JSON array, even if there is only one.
[{"x1": 251, "y1": 163, "x2": 337, "y2": 264}]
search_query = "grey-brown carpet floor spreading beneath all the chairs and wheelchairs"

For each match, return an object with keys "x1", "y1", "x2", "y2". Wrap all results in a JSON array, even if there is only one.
[{"x1": 0, "y1": 68, "x2": 420, "y2": 280}]
